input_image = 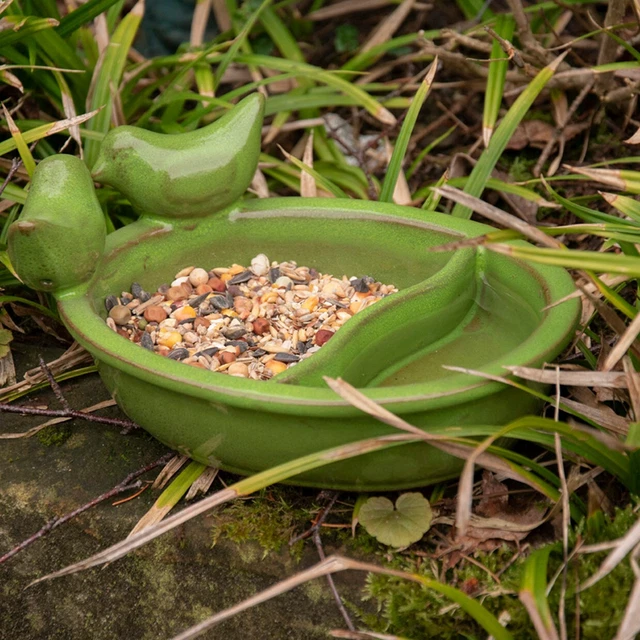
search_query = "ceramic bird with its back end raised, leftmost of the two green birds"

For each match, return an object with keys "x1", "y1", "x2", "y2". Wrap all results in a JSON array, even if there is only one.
[{"x1": 8, "y1": 155, "x2": 107, "y2": 291}]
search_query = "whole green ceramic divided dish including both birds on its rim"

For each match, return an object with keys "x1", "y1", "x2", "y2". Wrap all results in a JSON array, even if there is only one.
[{"x1": 9, "y1": 95, "x2": 579, "y2": 490}]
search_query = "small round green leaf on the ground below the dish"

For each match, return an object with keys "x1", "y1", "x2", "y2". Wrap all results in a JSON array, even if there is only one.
[{"x1": 359, "y1": 493, "x2": 433, "y2": 547}]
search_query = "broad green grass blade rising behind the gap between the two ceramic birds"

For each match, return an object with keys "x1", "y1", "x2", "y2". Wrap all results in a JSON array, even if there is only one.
[{"x1": 85, "y1": 0, "x2": 144, "y2": 168}]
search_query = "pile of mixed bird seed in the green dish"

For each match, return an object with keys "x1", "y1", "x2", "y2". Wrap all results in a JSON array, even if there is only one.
[{"x1": 105, "y1": 254, "x2": 397, "y2": 380}]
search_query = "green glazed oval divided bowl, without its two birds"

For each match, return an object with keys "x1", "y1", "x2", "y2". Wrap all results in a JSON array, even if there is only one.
[{"x1": 8, "y1": 94, "x2": 579, "y2": 490}]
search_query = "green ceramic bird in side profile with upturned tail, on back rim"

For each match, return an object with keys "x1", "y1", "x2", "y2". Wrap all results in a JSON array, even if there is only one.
[{"x1": 93, "y1": 93, "x2": 264, "y2": 218}]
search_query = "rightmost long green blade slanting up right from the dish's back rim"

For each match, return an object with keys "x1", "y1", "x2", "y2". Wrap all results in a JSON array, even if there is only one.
[{"x1": 452, "y1": 55, "x2": 564, "y2": 219}]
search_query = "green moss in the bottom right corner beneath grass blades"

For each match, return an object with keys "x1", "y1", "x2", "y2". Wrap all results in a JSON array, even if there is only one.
[{"x1": 360, "y1": 507, "x2": 636, "y2": 640}]
